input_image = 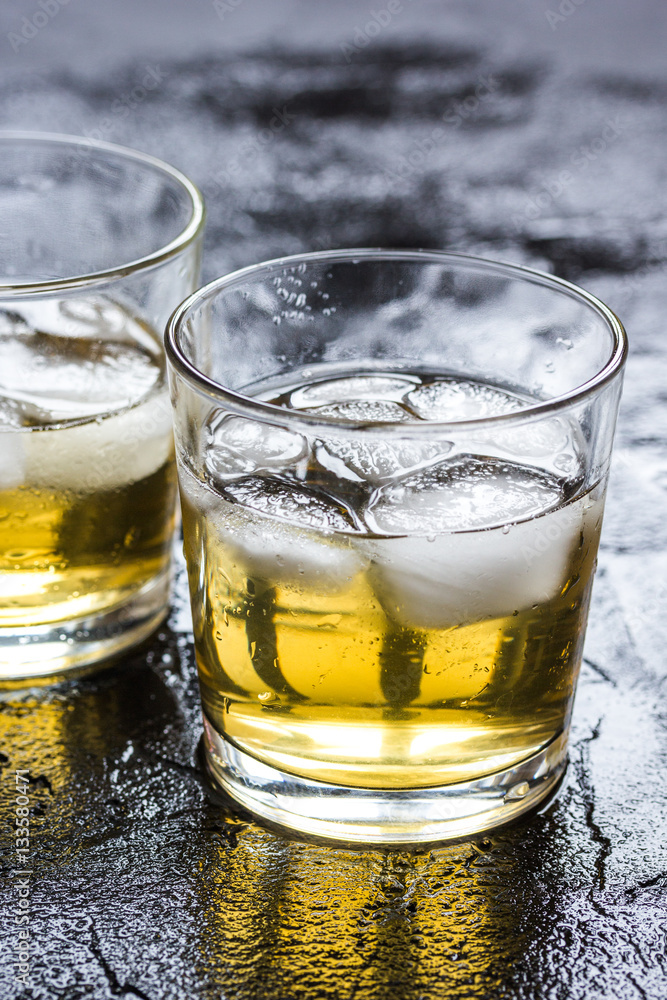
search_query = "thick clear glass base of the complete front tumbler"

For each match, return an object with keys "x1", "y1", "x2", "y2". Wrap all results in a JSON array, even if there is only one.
[{"x1": 204, "y1": 717, "x2": 567, "y2": 845}]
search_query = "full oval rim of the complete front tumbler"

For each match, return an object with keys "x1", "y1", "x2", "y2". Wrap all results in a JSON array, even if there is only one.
[{"x1": 164, "y1": 247, "x2": 628, "y2": 437}]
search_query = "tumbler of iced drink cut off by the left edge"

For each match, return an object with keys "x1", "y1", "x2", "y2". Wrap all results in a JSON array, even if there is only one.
[{"x1": 0, "y1": 133, "x2": 204, "y2": 686}]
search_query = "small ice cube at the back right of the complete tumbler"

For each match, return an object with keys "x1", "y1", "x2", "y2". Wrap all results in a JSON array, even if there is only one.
[{"x1": 405, "y1": 377, "x2": 528, "y2": 421}]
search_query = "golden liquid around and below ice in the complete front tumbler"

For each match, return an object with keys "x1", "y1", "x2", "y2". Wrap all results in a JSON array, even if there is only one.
[{"x1": 182, "y1": 473, "x2": 601, "y2": 788}]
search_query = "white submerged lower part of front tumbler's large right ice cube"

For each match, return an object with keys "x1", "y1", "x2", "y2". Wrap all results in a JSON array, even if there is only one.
[{"x1": 368, "y1": 484, "x2": 601, "y2": 628}]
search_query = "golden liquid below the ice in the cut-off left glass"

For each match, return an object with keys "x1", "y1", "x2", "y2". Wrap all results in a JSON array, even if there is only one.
[{"x1": 0, "y1": 461, "x2": 176, "y2": 628}]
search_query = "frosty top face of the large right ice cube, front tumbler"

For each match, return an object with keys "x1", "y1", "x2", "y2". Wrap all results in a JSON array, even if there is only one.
[{"x1": 366, "y1": 456, "x2": 562, "y2": 535}]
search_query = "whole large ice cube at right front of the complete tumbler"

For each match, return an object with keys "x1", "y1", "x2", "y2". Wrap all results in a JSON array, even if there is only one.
[{"x1": 368, "y1": 463, "x2": 601, "y2": 628}]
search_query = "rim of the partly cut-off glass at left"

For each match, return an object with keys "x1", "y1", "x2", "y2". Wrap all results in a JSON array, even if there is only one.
[{"x1": 0, "y1": 129, "x2": 206, "y2": 298}]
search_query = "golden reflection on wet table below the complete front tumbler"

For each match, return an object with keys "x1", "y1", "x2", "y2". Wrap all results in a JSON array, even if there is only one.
[{"x1": 196, "y1": 822, "x2": 523, "y2": 1000}]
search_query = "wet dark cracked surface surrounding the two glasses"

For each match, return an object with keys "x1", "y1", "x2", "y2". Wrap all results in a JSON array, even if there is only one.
[{"x1": 0, "y1": 0, "x2": 667, "y2": 1000}]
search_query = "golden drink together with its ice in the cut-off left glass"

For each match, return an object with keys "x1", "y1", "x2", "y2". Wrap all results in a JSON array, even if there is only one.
[{"x1": 0, "y1": 297, "x2": 176, "y2": 630}]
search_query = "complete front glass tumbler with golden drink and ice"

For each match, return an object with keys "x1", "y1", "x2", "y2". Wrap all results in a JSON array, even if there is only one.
[{"x1": 167, "y1": 250, "x2": 626, "y2": 843}]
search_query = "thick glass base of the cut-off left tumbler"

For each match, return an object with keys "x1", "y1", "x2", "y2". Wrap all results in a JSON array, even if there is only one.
[{"x1": 0, "y1": 569, "x2": 172, "y2": 688}]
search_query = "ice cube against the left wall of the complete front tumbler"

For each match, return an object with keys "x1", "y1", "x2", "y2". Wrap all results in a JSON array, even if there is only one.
[{"x1": 204, "y1": 414, "x2": 308, "y2": 481}]
